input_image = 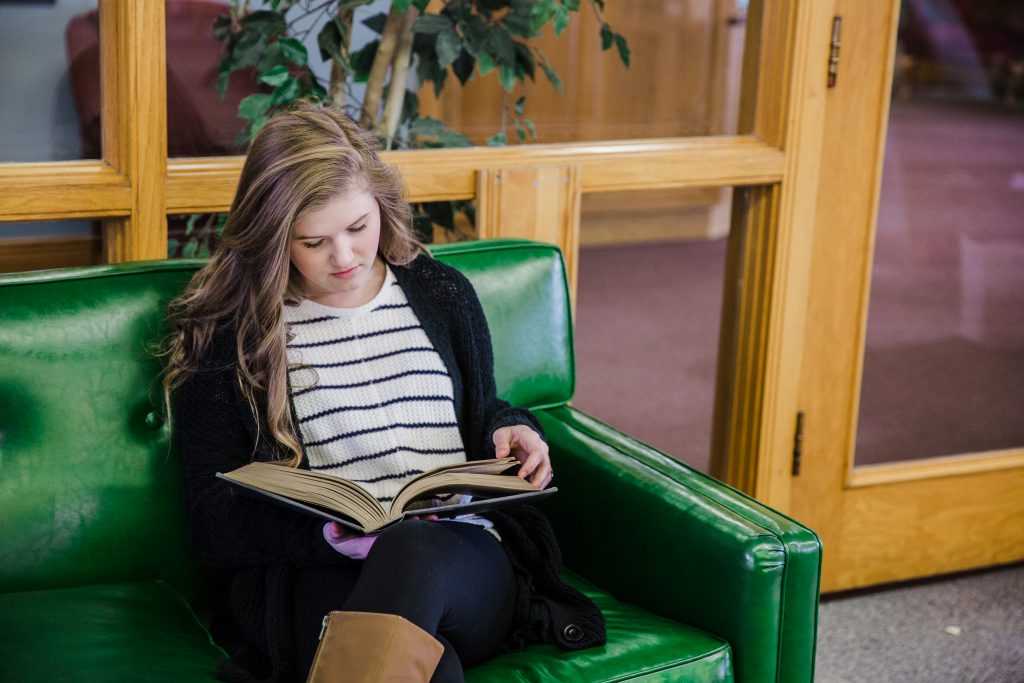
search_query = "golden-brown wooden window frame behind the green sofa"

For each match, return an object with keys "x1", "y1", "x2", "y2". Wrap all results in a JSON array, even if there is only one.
[{"x1": 0, "y1": 0, "x2": 834, "y2": 509}]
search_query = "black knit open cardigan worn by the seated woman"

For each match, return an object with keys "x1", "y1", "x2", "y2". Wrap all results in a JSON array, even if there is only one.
[{"x1": 172, "y1": 255, "x2": 604, "y2": 681}]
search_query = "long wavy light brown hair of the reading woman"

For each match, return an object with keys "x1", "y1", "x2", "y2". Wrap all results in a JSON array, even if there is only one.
[{"x1": 160, "y1": 101, "x2": 424, "y2": 467}]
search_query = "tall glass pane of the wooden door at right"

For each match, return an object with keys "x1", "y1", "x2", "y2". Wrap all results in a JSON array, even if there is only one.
[{"x1": 856, "y1": 2, "x2": 1024, "y2": 465}]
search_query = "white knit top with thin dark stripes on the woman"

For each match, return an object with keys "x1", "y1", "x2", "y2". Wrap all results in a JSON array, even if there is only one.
[{"x1": 285, "y1": 268, "x2": 466, "y2": 503}]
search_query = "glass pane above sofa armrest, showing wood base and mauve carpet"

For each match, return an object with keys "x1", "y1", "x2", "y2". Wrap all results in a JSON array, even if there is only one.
[{"x1": 573, "y1": 188, "x2": 732, "y2": 472}]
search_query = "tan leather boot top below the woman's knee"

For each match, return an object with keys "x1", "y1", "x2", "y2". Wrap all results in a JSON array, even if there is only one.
[{"x1": 306, "y1": 611, "x2": 444, "y2": 683}]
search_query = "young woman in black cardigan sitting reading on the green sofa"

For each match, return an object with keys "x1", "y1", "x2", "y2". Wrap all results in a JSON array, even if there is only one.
[{"x1": 164, "y1": 103, "x2": 604, "y2": 681}]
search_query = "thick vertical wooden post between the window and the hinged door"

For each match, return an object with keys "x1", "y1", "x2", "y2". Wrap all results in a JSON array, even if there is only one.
[{"x1": 712, "y1": 2, "x2": 833, "y2": 511}]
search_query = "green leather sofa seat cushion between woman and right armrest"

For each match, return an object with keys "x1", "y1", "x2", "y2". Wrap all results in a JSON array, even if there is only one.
[{"x1": 466, "y1": 572, "x2": 733, "y2": 683}]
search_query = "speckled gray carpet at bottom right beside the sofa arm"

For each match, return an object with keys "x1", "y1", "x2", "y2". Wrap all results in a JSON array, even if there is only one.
[{"x1": 815, "y1": 564, "x2": 1024, "y2": 683}]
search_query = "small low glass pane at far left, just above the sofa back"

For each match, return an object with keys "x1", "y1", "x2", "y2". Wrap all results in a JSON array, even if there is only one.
[{"x1": 0, "y1": 220, "x2": 101, "y2": 272}]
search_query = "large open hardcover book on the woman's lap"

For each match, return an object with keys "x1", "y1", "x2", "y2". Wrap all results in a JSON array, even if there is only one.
[{"x1": 211, "y1": 457, "x2": 558, "y2": 533}]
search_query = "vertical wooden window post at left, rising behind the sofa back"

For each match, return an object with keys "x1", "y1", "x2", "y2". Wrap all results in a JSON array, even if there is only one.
[{"x1": 99, "y1": 0, "x2": 167, "y2": 262}]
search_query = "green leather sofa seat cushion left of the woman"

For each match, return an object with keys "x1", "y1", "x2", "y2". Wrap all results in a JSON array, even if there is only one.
[{"x1": 0, "y1": 581, "x2": 224, "y2": 683}]
